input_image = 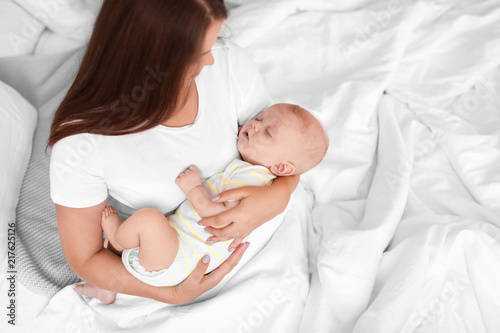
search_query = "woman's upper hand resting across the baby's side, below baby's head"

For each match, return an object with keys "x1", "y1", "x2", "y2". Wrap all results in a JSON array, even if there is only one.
[{"x1": 200, "y1": 176, "x2": 299, "y2": 249}]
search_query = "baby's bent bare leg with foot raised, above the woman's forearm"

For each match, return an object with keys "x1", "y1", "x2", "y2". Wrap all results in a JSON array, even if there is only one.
[{"x1": 102, "y1": 206, "x2": 179, "y2": 271}]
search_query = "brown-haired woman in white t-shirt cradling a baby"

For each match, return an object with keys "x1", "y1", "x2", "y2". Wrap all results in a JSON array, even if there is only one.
[{"x1": 48, "y1": 0, "x2": 298, "y2": 304}]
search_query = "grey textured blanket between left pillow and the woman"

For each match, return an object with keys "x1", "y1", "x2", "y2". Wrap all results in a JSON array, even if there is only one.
[{"x1": 0, "y1": 48, "x2": 83, "y2": 296}]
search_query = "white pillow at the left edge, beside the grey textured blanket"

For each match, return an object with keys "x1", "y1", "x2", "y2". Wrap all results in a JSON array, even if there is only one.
[{"x1": 0, "y1": 81, "x2": 37, "y2": 249}]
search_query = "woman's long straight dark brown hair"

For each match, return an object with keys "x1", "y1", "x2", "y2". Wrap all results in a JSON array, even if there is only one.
[{"x1": 47, "y1": 0, "x2": 227, "y2": 147}]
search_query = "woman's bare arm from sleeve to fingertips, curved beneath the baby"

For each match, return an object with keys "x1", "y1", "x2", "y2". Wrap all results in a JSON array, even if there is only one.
[{"x1": 56, "y1": 200, "x2": 248, "y2": 304}]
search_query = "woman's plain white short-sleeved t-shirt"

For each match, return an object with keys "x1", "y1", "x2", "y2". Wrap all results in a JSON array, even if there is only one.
[{"x1": 50, "y1": 40, "x2": 272, "y2": 216}]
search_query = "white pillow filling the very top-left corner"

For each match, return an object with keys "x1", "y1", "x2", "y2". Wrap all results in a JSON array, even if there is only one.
[{"x1": 0, "y1": 0, "x2": 45, "y2": 57}]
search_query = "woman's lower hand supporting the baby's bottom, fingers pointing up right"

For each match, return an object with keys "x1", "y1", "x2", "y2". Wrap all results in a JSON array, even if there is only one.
[{"x1": 167, "y1": 242, "x2": 250, "y2": 304}]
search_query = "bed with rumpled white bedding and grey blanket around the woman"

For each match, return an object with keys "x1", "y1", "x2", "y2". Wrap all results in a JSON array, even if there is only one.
[{"x1": 0, "y1": 0, "x2": 500, "y2": 333}]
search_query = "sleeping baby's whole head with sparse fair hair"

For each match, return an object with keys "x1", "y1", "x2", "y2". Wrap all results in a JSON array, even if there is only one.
[{"x1": 238, "y1": 103, "x2": 329, "y2": 176}]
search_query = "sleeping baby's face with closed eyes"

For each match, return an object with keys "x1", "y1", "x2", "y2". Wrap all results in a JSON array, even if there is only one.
[{"x1": 238, "y1": 104, "x2": 305, "y2": 171}]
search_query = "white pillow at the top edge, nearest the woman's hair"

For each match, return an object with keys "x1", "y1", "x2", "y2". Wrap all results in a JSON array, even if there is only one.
[{"x1": 13, "y1": 0, "x2": 97, "y2": 41}]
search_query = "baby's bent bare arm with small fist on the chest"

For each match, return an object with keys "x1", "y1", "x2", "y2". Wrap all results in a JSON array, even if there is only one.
[{"x1": 175, "y1": 165, "x2": 240, "y2": 218}]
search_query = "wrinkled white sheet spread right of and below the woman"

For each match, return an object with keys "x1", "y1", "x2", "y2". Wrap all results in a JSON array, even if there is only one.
[{"x1": 6, "y1": 0, "x2": 500, "y2": 333}]
